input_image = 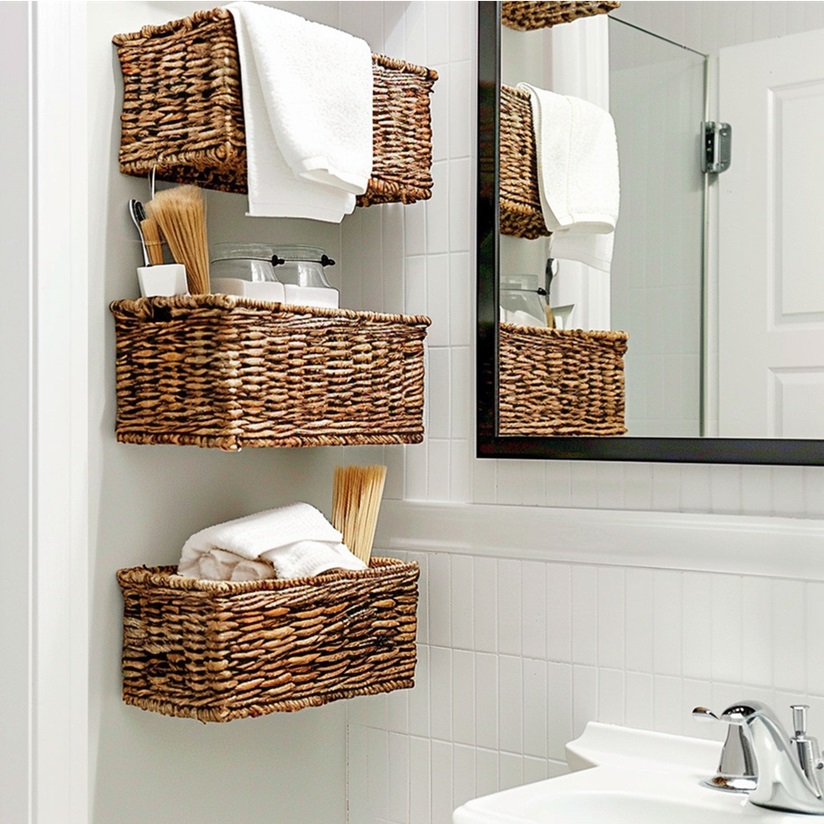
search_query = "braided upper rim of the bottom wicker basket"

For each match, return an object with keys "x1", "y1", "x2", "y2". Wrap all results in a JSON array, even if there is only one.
[{"x1": 117, "y1": 556, "x2": 420, "y2": 595}]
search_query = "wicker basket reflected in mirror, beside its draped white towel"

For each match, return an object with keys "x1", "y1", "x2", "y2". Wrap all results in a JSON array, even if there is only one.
[{"x1": 498, "y1": 86, "x2": 549, "y2": 240}]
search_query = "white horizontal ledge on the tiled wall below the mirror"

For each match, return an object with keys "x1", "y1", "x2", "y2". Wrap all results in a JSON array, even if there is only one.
[{"x1": 375, "y1": 500, "x2": 824, "y2": 580}]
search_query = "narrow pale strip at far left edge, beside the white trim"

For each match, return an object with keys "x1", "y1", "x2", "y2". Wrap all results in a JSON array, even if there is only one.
[{"x1": 0, "y1": 3, "x2": 32, "y2": 821}]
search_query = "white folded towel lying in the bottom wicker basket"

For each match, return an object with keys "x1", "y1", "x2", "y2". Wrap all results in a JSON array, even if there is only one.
[{"x1": 177, "y1": 503, "x2": 366, "y2": 581}]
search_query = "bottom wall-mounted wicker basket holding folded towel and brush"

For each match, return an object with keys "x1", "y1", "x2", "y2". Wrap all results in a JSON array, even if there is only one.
[{"x1": 117, "y1": 558, "x2": 419, "y2": 722}]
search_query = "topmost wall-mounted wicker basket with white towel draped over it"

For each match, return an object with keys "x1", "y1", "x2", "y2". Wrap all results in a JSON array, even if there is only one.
[{"x1": 112, "y1": 9, "x2": 438, "y2": 206}]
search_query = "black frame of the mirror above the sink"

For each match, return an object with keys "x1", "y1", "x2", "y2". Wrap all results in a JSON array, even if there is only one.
[{"x1": 476, "y1": 0, "x2": 824, "y2": 466}]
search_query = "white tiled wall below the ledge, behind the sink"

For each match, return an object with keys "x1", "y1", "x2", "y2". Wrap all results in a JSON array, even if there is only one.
[{"x1": 349, "y1": 551, "x2": 824, "y2": 824}]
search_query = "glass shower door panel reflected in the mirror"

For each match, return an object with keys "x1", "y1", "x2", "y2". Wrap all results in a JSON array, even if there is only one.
[{"x1": 609, "y1": 15, "x2": 707, "y2": 437}]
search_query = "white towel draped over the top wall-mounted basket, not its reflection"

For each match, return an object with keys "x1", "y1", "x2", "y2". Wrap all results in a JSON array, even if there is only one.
[{"x1": 226, "y1": 2, "x2": 372, "y2": 223}]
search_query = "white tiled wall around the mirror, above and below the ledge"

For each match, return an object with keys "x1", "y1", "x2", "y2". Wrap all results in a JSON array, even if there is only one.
[{"x1": 341, "y1": 0, "x2": 824, "y2": 824}]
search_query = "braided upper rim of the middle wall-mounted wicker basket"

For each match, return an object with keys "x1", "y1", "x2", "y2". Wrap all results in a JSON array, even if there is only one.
[{"x1": 109, "y1": 294, "x2": 432, "y2": 327}]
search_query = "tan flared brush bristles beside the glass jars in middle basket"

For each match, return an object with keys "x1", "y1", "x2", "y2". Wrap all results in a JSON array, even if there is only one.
[{"x1": 147, "y1": 186, "x2": 210, "y2": 295}]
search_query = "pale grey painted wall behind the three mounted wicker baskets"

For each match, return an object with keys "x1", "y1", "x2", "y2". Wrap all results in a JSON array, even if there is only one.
[{"x1": 88, "y1": 2, "x2": 364, "y2": 824}]
